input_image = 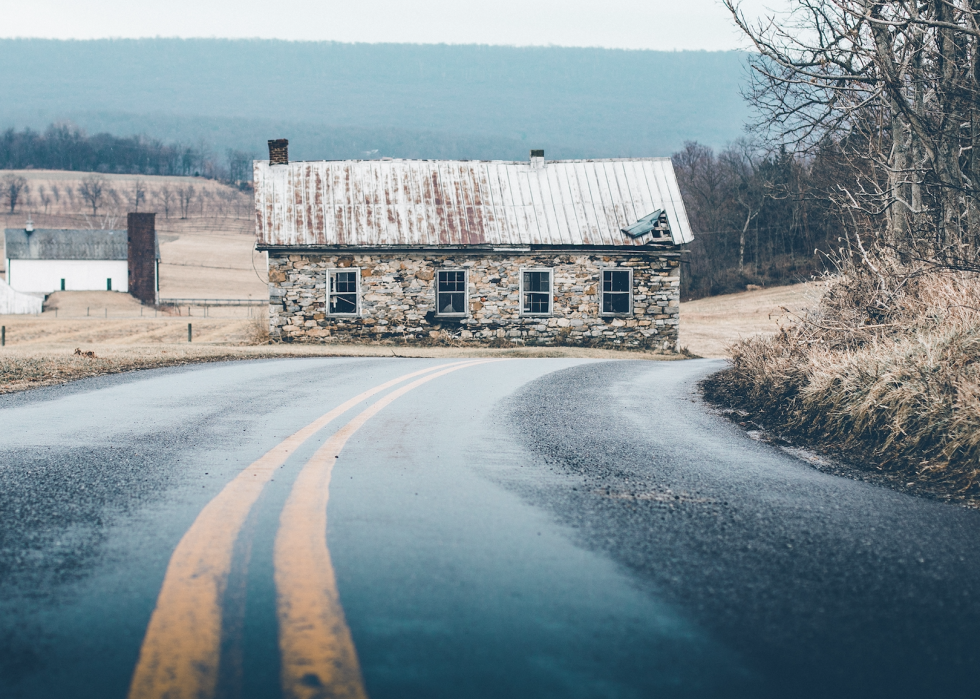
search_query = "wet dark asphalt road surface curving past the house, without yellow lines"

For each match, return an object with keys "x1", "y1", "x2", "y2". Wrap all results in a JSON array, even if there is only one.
[{"x1": 0, "y1": 359, "x2": 980, "y2": 699}]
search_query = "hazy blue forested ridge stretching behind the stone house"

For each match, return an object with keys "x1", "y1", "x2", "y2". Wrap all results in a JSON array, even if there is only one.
[{"x1": 0, "y1": 39, "x2": 747, "y2": 159}]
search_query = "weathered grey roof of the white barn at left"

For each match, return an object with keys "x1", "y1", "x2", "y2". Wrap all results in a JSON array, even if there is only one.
[{"x1": 4, "y1": 228, "x2": 160, "y2": 260}]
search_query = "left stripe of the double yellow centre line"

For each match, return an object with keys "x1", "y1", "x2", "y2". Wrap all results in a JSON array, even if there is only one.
[{"x1": 129, "y1": 360, "x2": 480, "y2": 699}]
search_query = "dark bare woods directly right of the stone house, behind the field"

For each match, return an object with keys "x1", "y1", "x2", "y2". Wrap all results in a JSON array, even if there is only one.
[{"x1": 672, "y1": 142, "x2": 846, "y2": 298}]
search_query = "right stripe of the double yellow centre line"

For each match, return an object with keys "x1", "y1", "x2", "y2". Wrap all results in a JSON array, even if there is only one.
[{"x1": 273, "y1": 359, "x2": 502, "y2": 699}]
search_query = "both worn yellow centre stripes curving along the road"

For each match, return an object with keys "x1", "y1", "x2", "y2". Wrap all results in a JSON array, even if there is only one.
[{"x1": 129, "y1": 359, "x2": 501, "y2": 699}]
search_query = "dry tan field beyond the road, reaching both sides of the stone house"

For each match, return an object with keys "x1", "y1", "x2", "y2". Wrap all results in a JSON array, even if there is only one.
[{"x1": 0, "y1": 285, "x2": 816, "y2": 393}]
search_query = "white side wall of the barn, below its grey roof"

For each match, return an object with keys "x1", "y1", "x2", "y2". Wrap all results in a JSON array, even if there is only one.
[{"x1": 7, "y1": 259, "x2": 129, "y2": 293}]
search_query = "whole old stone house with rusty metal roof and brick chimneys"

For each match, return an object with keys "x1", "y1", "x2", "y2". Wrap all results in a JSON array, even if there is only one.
[{"x1": 254, "y1": 140, "x2": 693, "y2": 352}]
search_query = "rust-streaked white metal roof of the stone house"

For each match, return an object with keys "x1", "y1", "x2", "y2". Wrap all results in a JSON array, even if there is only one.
[{"x1": 254, "y1": 158, "x2": 694, "y2": 247}]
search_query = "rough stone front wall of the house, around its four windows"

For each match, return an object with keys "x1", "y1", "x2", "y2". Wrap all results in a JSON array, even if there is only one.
[{"x1": 269, "y1": 251, "x2": 680, "y2": 352}]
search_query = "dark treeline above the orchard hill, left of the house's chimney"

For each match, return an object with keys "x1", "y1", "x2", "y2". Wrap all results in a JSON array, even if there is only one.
[{"x1": 0, "y1": 124, "x2": 252, "y2": 182}]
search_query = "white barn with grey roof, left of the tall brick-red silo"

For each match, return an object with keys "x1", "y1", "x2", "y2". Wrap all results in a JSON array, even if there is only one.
[{"x1": 4, "y1": 226, "x2": 138, "y2": 294}]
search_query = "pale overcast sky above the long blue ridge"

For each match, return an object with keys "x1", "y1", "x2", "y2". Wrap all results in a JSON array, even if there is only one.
[{"x1": 0, "y1": 0, "x2": 779, "y2": 51}]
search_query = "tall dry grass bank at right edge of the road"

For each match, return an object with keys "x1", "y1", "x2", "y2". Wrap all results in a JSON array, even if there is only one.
[{"x1": 705, "y1": 256, "x2": 980, "y2": 504}]
